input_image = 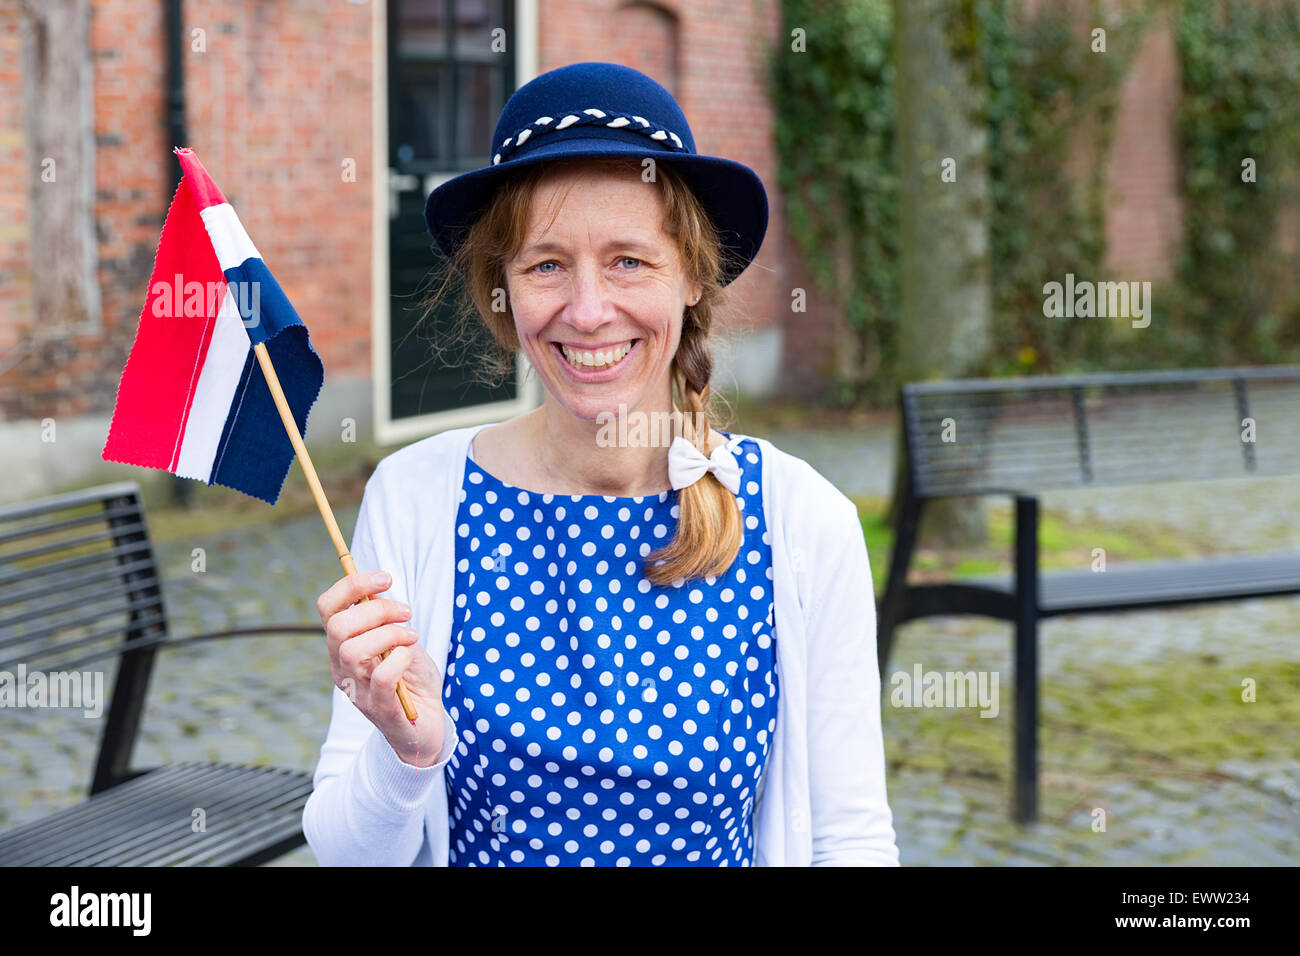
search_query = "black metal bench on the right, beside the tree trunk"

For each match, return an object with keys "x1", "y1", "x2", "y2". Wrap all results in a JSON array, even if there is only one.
[{"x1": 878, "y1": 365, "x2": 1300, "y2": 822}]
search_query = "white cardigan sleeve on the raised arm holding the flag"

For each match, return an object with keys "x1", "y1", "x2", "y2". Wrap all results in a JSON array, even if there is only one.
[{"x1": 303, "y1": 462, "x2": 458, "y2": 866}]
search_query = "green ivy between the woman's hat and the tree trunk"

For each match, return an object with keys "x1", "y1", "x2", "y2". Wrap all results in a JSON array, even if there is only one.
[{"x1": 770, "y1": 0, "x2": 898, "y2": 401}]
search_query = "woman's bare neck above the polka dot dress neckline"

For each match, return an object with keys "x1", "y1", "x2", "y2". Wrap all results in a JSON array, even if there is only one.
[{"x1": 529, "y1": 395, "x2": 672, "y2": 497}]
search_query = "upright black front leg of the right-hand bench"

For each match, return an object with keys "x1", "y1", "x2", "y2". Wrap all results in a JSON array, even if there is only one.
[{"x1": 1015, "y1": 496, "x2": 1039, "y2": 823}]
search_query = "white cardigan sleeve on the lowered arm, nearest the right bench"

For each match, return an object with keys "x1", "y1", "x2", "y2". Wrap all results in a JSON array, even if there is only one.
[{"x1": 801, "y1": 486, "x2": 898, "y2": 866}]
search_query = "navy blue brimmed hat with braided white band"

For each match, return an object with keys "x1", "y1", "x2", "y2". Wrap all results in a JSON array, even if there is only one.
[{"x1": 424, "y1": 62, "x2": 767, "y2": 285}]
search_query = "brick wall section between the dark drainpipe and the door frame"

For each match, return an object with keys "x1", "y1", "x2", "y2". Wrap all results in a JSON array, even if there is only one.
[{"x1": 178, "y1": 0, "x2": 374, "y2": 381}]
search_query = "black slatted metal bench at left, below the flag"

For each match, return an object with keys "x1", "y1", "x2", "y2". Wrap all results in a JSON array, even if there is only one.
[{"x1": 0, "y1": 481, "x2": 321, "y2": 866}]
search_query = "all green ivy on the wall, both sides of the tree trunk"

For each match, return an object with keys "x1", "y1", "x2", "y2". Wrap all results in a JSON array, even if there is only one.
[{"x1": 771, "y1": 0, "x2": 1300, "y2": 403}]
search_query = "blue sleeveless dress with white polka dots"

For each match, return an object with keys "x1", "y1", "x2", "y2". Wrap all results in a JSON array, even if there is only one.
[{"x1": 443, "y1": 440, "x2": 779, "y2": 866}]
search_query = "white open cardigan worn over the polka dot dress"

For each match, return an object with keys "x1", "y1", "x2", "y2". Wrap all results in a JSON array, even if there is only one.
[{"x1": 303, "y1": 425, "x2": 898, "y2": 866}]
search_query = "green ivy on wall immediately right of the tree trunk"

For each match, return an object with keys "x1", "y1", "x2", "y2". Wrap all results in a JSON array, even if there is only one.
[{"x1": 976, "y1": 0, "x2": 1149, "y2": 375}]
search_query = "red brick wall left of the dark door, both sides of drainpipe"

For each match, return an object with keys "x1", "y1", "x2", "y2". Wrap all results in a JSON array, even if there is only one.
[{"x1": 0, "y1": 0, "x2": 372, "y2": 420}]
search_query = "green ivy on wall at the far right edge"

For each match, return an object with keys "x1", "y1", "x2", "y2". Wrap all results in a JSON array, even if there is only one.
[{"x1": 1160, "y1": 0, "x2": 1300, "y2": 364}]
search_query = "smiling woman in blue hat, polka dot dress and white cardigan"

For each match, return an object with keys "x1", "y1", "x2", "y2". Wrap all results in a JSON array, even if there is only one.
[{"x1": 303, "y1": 62, "x2": 898, "y2": 866}]
